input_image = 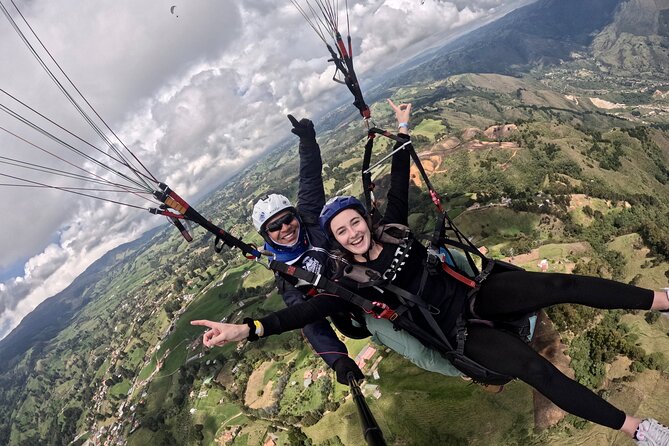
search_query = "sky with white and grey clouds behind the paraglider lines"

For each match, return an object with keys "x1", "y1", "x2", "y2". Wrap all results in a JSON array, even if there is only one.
[{"x1": 0, "y1": 0, "x2": 532, "y2": 339}]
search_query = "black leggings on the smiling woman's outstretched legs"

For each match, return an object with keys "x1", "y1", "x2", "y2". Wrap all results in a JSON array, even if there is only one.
[{"x1": 465, "y1": 271, "x2": 653, "y2": 429}]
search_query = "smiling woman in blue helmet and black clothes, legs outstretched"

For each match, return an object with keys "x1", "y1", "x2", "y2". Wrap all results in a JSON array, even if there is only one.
[{"x1": 193, "y1": 101, "x2": 669, "y2": 446}]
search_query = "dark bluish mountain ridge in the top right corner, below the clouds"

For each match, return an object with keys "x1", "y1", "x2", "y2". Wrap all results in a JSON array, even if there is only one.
[{"x1": 386, "y1": 0, "x2": 669, "y2": 86}]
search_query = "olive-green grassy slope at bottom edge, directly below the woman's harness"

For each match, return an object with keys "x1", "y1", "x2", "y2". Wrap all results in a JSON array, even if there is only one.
[{"x1": 306, "y1": 354, "x2": 533, "y2": 445}]
